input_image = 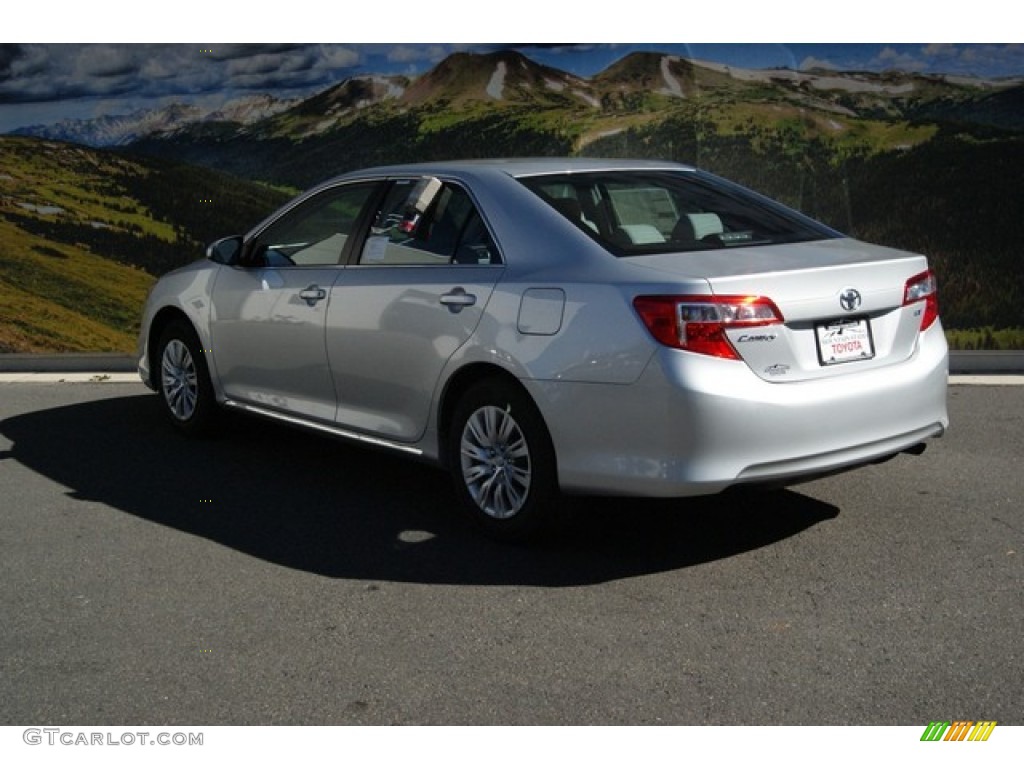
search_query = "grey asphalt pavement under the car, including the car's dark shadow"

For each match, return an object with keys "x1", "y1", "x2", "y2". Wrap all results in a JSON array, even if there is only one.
[{"x1": 0, "y1": 383, "x2": 1024, "y2": 727}]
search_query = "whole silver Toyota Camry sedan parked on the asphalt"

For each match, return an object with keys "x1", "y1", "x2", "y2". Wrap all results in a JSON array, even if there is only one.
[{"x1": 138, "y1": 159, "x2": 948, "y2": 540}]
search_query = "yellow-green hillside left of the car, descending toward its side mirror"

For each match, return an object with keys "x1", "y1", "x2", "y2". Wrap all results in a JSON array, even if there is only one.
[{"x1": 0, "y1": 137, "x2": 287, "y2": 352}]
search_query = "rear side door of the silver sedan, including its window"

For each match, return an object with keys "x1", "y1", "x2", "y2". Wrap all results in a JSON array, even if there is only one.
[{"x1": 327, "y1": 178, "x2": 503, "y2": 441}]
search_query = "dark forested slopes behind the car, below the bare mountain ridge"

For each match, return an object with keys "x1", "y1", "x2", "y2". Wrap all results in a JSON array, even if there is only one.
[{"x1": 139, "y1": 91, "x2": 1024, "y2": 339}]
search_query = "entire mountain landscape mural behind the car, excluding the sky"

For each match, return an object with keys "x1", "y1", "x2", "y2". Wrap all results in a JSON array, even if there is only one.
[{"x1": 0, "y1": 50, "x2": 1024, "y2": 351}]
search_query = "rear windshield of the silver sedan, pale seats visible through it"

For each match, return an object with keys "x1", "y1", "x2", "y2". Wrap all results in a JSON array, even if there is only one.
[{"x1": 519, "y1": 171, "x2": 842, "y2": 256}]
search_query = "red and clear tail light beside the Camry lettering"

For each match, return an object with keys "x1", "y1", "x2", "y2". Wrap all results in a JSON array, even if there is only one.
[{"x1": 633, "y1": 296, "x2": 782, "y2": 360}]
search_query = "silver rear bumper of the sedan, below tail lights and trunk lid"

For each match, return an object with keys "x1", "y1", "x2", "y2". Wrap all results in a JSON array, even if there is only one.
[{"x1": 525, "y1": 324, "x2": 948, "y2": 497}]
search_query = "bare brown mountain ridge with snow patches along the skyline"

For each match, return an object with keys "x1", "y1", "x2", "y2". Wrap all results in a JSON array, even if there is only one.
[{"x1": 11, "y1": 49, "x2": 1024, "y2": 146}]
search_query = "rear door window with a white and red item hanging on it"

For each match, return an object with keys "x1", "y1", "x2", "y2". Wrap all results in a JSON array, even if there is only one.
[{"x1": 359, "y1": 178, "x2": 501, "y2": 265}]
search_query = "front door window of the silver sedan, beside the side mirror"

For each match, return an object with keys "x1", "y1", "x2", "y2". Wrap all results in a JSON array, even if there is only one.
[{"x1": 250, "y1": 183, "x2": 379, "y2": 266}]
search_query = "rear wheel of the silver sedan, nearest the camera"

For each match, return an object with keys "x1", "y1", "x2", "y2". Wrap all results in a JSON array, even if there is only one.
[{"x1": 447, "y1": 379, "x2": 559, "y2": 542}]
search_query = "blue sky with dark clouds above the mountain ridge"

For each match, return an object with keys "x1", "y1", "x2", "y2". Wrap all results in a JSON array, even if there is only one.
[{"x1": 0, "y1": 43, "x2": 1024, "y2": 132}]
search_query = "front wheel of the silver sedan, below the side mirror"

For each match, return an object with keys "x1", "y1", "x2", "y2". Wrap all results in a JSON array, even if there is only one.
[{"x1": 157, "y1": 319, "x2": 217, "y2": 436}]
